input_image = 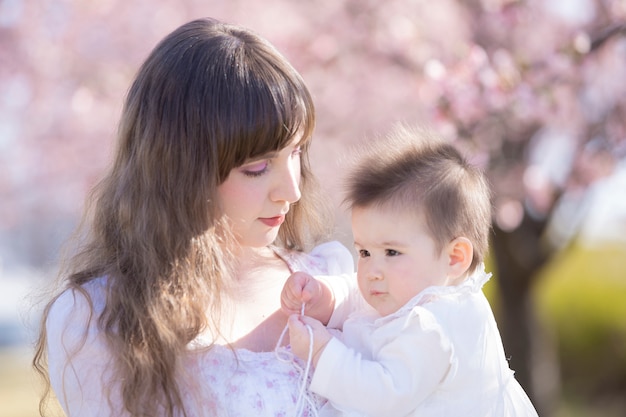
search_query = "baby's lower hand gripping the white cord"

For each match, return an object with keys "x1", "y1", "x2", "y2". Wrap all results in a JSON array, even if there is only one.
[{"x1": 288, "y1": 314, "x2": 332, "y2": 366}]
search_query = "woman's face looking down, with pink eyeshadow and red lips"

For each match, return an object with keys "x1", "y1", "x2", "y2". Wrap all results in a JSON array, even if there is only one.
[{"x1": 217, "y1": 136, "x2": 301, "y2": 247}]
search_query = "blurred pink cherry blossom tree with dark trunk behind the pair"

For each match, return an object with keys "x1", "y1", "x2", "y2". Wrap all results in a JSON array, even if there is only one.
[{"x1": 0, "y1": 0, "x2": 626, "y2": 415}]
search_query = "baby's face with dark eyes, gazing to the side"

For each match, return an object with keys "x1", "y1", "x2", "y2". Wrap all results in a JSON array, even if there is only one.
[{"x1": 352, "y1": 207, "x2": 450, "y2": 316}]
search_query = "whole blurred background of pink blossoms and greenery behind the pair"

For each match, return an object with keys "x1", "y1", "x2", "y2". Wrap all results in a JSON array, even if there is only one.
[{"x1": 0, "y1": 0, "x2": 626, "y2": 417}]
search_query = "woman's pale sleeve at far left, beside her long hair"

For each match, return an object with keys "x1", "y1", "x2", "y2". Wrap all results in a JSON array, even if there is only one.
[{"x1": 46, "y1": 290, "x2": 127, "y2": 417}]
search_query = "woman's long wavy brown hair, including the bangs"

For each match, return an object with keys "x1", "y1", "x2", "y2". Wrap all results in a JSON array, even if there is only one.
[{"x1": 33, "y1": 19, "x2": 325, "y2": 416}]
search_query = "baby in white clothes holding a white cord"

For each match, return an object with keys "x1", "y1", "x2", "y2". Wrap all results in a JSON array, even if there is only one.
[{"x1": 281, "y1": 127, "x2": 537, "y2": 417}]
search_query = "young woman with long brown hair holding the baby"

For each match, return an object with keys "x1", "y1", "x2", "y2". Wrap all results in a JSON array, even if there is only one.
[{"x1": 34, "y1": 19, "x2": 353, "y2": 416}]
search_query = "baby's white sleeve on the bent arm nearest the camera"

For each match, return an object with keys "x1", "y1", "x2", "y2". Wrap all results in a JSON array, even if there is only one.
[{"x1": 310, "y1": 311, "x2": 453, "y2": 417}]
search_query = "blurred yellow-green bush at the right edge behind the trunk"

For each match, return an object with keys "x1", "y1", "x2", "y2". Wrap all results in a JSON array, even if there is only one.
[{"x1": 535, "y1": 240, "x2": 626, "y2": 398}]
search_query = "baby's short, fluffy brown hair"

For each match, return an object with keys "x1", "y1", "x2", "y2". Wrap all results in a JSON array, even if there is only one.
[{"x1": 344, "y1": 125, "x2": 491, "y2": 272}]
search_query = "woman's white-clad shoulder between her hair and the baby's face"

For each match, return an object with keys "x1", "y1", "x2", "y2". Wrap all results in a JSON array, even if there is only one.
[{"x1": 273, "y1": 241, "x2": 354, "y2": 275}]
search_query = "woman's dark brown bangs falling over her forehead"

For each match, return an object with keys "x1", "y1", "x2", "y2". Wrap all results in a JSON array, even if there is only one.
[{"x1": 212, "y1": 41, "x2": 315, "y2": 180}]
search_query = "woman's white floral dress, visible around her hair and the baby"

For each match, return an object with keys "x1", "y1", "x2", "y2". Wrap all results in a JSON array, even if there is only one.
[{"x1": 47, "y1": 242, "x2": 354, "y2": 417}]
